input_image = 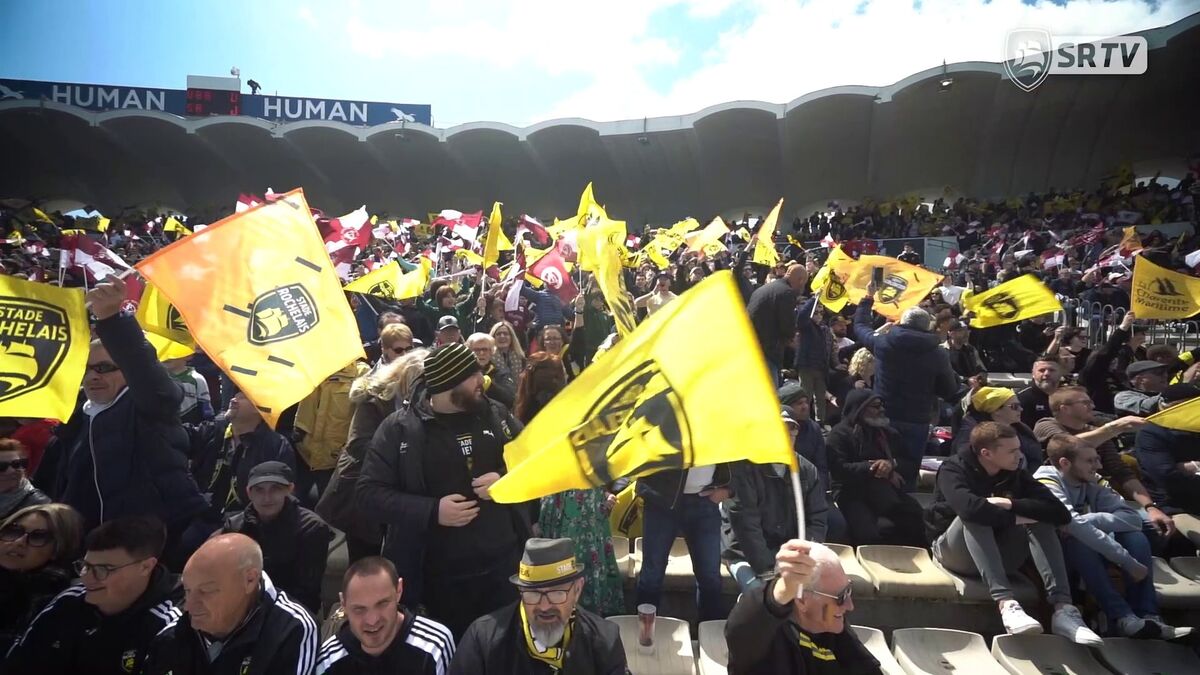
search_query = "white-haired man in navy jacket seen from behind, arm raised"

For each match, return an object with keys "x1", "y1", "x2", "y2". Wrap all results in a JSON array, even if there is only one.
[{"x1": 854, "y1": 283, "x2": 959, "y2": 491}]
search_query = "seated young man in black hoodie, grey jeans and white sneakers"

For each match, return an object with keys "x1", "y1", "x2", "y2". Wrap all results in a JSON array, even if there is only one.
[{"x1": 925, "y1": 422, "x2": 1102, "y2": 646}]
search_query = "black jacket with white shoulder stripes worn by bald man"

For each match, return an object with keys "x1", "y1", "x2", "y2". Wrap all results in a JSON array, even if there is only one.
[{"x1": 142, "y1": 573, "x2": 320, "y2": 675}]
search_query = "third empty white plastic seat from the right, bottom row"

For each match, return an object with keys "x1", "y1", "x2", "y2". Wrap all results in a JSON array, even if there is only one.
[{"x1": 892, "y1": 628, "x2": 1007, "y2": 675}]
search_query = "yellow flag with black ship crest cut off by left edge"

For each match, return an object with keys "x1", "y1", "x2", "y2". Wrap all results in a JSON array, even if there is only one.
[{"x1": 0, "y1": 275, "x2": 90, "y2": 422}]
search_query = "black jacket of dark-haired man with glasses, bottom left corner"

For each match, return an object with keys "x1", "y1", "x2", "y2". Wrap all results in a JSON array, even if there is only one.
[{"x1": 0, "y1": 566, "x2": 182, "y2": 675}]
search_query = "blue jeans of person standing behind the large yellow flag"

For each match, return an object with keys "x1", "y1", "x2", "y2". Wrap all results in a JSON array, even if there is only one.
[{"x1": 637, "y1": 495, "x2": 724, "y2": 621}]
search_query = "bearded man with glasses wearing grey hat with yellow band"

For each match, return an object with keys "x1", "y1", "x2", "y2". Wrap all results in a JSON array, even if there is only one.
[{"x1": 450, "y1": 538, "x2": 629, "y2": 675}]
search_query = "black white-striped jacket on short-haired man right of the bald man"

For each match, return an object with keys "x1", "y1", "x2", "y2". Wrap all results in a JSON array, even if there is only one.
[{"x1": 313, "y1": 607, "x2": 454, "y2": 675}]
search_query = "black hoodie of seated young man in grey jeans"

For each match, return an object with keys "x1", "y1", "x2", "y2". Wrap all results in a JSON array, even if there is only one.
[{"x1": 925, "y1": 447, "x2": 1070, "y2": 543}]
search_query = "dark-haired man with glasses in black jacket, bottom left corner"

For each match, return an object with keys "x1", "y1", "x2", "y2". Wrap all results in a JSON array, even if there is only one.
[{"x1": 0, "y1": 516, "x2": 182, "y2": 675}]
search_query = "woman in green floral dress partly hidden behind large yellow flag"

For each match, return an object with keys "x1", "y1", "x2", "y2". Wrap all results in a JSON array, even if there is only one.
[{"x1": 514, "y1": 352, "x2": 625, "y2": 616}]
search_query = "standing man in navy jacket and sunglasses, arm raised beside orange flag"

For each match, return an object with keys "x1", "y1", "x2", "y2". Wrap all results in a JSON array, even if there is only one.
[{"x1": 37, "y1": 277, "x2": 208, "y2": 566}]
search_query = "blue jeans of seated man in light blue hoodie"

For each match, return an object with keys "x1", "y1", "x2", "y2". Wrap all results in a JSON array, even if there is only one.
[{"x1": 1062, "y1": 532, "x2": 1158, "y2": 621}]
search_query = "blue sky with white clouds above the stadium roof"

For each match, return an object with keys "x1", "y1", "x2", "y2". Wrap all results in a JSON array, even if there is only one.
[{"x1": 0, "y1": 0, "x2": 1200, "y2": 127}]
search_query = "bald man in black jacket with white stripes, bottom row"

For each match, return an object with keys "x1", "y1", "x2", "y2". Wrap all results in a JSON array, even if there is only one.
[{"x1": 143, "y1": 534, "x2": 319, "y2": 675}]
